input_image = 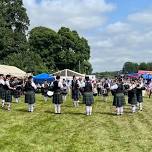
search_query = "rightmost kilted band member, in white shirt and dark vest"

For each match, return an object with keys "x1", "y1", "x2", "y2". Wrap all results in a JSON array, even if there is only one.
[{"x1": 136, "y1": 80, "x2": 145, "y2": 111}]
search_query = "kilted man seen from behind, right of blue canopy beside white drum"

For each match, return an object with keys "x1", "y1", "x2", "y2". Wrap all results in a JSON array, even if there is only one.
[{"x1": 51, "y1": 75, "x2": 63, "y2": 114}]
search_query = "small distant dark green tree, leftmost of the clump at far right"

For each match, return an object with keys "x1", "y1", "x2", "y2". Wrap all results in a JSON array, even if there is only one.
[{"x1": 123, "y1": 62, "x2": 138, "y2": 73}]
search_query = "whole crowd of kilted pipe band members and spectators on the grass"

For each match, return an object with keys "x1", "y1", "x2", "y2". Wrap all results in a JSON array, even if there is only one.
[{"x1": 0, "y1": 74, "x2": 152, "y2": 115}]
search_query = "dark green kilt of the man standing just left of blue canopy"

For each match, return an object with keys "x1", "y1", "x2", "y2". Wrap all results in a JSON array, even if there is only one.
[{"x1": 25, "y1": 91, "x2": 35, "y2": 104}]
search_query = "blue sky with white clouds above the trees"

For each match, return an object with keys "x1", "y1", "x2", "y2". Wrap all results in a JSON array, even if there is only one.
[{"x1": 23, "y1": 0, "x2": 152, "y2": 72}]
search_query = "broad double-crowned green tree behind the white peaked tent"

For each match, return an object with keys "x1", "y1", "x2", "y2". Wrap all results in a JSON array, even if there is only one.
[{"x1": 29, "y1": 27, "x2": 92, "y2": 73}]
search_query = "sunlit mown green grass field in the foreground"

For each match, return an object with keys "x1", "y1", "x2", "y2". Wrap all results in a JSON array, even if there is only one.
[{"x1": 0, "y1": 95, "x2": 152, "y2": 152}]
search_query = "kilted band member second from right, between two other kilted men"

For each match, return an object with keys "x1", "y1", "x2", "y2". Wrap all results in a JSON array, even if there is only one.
[{"x1": 128, "y1": 80, "x2": 137, "y2": 113}]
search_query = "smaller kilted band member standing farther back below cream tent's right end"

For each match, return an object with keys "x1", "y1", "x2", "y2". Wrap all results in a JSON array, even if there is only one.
[{"x1": 11, "y1": 77, "x2": 20, "y2": 103}]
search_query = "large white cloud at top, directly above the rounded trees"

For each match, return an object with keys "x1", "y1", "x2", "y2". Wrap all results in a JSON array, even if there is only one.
[{"x1": 23, "y1": 0, "x2": 115, "y2": 32}]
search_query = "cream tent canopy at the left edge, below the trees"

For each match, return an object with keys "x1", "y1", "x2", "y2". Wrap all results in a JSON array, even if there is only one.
[{"x1": 0, "y1": 65, "x2": 26, "y2": 78}]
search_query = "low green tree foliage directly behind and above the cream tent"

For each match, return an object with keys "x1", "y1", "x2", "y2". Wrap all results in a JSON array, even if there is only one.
[{"x1": 3, "y1": 51, "x2": 48, "y2": 73}]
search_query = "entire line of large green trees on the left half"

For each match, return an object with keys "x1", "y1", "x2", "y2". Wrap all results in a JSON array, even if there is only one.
[{"x1": 0, "y1": 0, "x2": 92, "y2": 74}]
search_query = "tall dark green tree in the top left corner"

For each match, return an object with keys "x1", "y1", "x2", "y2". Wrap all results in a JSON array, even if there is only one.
[{"x1": 0, "y1": 0, "x2": 29, "y2": 59}]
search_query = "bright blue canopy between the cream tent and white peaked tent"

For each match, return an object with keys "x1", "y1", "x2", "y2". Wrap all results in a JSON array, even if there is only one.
[{"x1": 33, "y1": 73, "x2": 55, "y2": 83}]
